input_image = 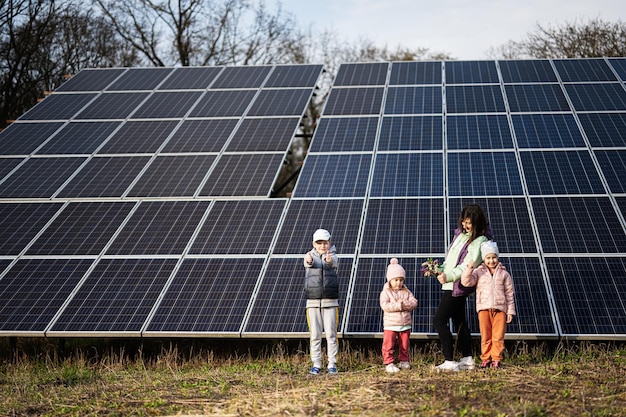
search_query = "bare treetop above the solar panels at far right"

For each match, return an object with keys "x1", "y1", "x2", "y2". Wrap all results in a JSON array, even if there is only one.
[{"x1": 489, "y1": 18, "x2": 626, "y2": 59}]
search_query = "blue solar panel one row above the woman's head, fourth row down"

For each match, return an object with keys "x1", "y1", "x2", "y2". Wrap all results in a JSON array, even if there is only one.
[{"x1": 448, "y1": 152, "x2": 522, "y2": 196}]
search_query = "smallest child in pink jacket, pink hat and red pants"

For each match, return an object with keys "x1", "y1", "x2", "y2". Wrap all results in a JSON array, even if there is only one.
[{"x1": 380, "y1": 258, "x2": 417, "y2": 372}]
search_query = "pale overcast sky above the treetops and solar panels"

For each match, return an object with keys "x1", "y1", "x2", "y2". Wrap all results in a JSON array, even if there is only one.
[{"x1": 276, "y1": 0, "x2": 626, "y2": 60}]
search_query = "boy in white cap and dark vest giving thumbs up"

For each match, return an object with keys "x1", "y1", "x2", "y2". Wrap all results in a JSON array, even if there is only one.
[{"x1": 304, "y1": 229, "x2": 339, "y2": 375}]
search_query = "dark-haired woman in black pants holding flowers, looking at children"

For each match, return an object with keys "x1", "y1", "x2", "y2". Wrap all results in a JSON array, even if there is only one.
[{"x1": 433, "y1": 204, "x2": 489, "y2": 371}]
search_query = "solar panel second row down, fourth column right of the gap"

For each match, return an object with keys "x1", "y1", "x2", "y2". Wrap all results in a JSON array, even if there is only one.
[{"x1": 504, "y1": 84, "x2": 570, "y2": 113}]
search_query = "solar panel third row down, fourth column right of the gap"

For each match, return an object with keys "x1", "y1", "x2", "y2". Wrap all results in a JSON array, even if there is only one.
[{"x1": 511, "y1": 114, "x2": 585, "y2": 148}]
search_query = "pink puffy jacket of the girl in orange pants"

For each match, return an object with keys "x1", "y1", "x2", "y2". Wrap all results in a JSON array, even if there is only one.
[{"x1": 461, "y1": 262, "x2": 515, "y2": 315}]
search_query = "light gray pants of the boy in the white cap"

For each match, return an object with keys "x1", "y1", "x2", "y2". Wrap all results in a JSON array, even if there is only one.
[{"x1": 306, "y1": 307, "x2": 339, "y2": 368}]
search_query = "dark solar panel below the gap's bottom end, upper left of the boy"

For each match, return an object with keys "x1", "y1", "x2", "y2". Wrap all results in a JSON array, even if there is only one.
[{"x1": 189, "y1": 199, "x2": 285, "y2": 255}]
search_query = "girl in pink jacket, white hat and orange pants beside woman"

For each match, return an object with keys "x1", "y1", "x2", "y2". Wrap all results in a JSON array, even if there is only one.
[{"x1": 461, "y1": 240, "x2": 515, "y2": 368}]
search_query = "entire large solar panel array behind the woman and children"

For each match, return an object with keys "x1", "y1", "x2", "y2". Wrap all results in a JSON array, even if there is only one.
[{"x1": 0, "y1": 58, "x2": 626, "y2": 339}]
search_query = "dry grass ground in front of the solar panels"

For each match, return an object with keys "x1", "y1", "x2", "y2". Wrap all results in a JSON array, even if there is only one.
[{"x1": 0, "y1": 341, "x2": 626, "y2": 417}]
